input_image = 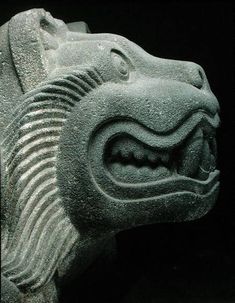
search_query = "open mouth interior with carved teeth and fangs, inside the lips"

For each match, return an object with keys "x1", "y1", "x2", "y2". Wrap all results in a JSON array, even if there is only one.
[{"x1": 104, "y1": 128, "x2": 216, "y2": 183}]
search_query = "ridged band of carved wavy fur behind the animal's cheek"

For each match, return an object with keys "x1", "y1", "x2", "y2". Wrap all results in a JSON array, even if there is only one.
[{"x1": 2, "y1": 67, "x2": 103, "y2": 290}]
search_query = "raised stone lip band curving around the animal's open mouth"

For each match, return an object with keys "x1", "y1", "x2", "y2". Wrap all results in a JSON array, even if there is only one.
[{"x1": 88, "y1": 112, "x2": 219, "y2": 201}]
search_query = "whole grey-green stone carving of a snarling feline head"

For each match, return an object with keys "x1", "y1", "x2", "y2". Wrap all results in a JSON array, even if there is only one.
[{"x1": 0, "y1": 9, "x2": 219, "y2": 303}]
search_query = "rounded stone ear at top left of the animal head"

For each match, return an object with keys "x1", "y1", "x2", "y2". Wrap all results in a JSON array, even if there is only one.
[{"x1": 9, "y1": 9, "x2": 68, "y2": 92}]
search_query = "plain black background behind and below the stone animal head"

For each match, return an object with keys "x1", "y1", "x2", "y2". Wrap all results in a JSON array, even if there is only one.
[{"x1": 0, "y1": 0, "x2": 235, "y2": 303}]
